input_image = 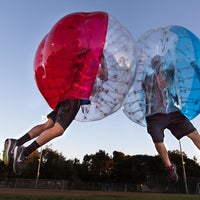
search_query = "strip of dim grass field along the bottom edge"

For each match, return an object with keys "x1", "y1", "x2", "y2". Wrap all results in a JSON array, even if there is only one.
[{"x1": 0, "y1": 188, "x2": 200, "y2": 200}]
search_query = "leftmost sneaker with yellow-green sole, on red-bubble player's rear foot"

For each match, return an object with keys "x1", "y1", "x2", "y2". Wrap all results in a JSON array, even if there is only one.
[{"x1": 3, "y1": 139, "x2": 17, "y2": 166}]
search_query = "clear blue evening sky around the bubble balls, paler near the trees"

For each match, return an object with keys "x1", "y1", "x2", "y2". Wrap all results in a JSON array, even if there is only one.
[{"x1": 0, "y1": 0, "x2": 200, "y2": 162}]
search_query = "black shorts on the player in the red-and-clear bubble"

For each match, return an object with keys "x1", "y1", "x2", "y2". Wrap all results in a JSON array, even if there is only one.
[{"x1": 47, "y1": 99, "x2": 81, "y2": 130}]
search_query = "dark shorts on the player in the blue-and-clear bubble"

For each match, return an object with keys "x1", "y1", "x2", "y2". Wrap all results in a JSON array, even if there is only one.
[{"x1": 146, "y1": 112, "x2": 196, "y2": 143}]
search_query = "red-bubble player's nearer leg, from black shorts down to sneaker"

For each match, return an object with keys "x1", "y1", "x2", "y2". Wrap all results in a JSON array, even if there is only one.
[{"x1": 13, "y1": 99, "x2": 80, "y2": 174}]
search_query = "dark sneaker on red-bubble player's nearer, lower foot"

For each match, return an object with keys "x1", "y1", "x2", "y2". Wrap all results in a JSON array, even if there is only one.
[{"x1": 13, "y1": 146, "x2": 26, "y2": 175}]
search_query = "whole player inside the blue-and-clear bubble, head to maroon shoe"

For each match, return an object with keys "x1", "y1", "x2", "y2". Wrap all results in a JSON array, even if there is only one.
[{"x1": 142, "y1": 55, "x2": 200, "y2": 183}]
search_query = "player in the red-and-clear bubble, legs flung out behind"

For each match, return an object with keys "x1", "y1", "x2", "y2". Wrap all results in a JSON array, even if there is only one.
[{"x1": 3, "y1": 52, "x2": 108, "y2": 175}]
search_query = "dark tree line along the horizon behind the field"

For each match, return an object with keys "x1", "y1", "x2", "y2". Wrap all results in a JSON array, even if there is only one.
[{"x1": 0, "y1": 147, "x2": 200, "y2": 183}]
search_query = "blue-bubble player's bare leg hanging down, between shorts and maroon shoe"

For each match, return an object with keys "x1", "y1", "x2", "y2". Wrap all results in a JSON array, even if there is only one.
[{"x1": 155, "y1": 142, "x2": 172, "y2": 167}]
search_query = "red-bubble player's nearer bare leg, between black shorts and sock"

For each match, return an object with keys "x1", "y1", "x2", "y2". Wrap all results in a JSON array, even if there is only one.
[{"x1": 36, "y1": 123, "x2": 64, "y2": 146}]
